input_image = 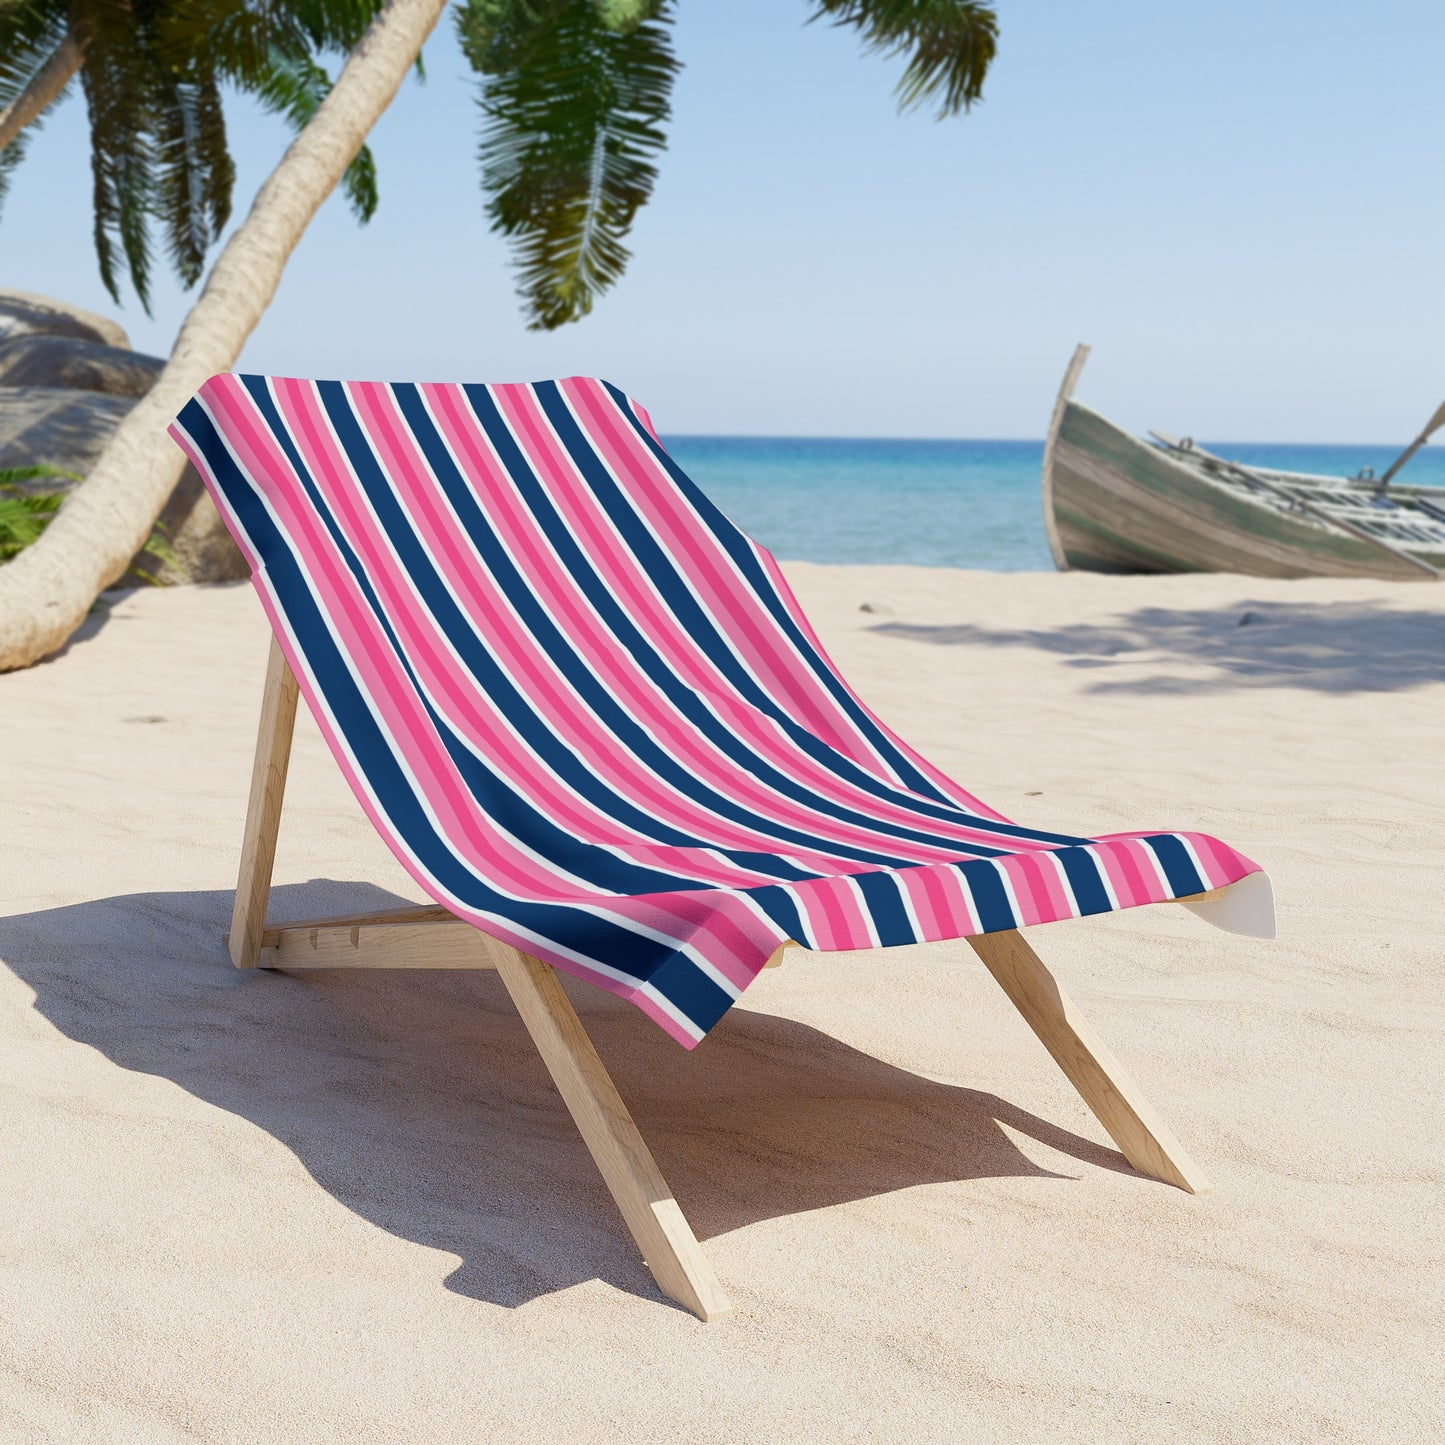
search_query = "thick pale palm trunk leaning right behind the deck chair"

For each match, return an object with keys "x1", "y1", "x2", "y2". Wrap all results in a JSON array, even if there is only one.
[{"x1": 0, "y1": 0, "x2": 447, "y2": 670}]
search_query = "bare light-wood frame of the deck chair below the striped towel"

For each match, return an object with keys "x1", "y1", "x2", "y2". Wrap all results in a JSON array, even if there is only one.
[{"x1": 223, "y1": 636, "x2": 1222, "y2": 1321}]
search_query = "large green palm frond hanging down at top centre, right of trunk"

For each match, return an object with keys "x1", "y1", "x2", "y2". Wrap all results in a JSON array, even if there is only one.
[{"x1": 458, "y1": 0, "x2": 679, "y2": 331}]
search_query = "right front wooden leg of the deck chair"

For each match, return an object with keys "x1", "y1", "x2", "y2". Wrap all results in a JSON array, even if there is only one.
[{"x1": 968, "y1": 931, "x2": 1209, "y2": 1194}]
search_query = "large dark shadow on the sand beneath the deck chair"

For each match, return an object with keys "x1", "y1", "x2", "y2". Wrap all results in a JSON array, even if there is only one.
[{"x1": 0, "y1": 880, "x2": 1131, "y2": 1306}]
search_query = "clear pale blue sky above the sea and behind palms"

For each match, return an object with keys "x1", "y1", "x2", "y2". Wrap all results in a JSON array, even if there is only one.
[{"x1": 8, "y1": 0, "x2": 1445, "y2": 442}]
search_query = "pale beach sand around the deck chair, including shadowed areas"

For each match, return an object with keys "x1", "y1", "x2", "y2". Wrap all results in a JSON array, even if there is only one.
[{"x1": 0, "y1": 565, "x2": 1445, "y2": 1445}]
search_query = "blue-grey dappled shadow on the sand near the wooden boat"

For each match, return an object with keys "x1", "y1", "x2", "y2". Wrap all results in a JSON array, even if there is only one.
[{"x1": 871, "y1": 601, "x2": 1445, "y2": 694}]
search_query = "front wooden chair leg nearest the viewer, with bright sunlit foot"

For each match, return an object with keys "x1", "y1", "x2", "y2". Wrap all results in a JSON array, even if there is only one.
[{"x1": 494, "y1": 948, "x2": 733, "y2": 1319}]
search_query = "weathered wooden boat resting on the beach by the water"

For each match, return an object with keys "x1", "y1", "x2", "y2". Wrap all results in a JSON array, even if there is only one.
[{"x1": 1043, "y1": 347, "x2": 1445, "y2": 579}]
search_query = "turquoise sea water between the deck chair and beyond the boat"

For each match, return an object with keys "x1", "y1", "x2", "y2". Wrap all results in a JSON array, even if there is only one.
[{"x1": 665, "y1": 436, "x2": 1445, "y2": 572}]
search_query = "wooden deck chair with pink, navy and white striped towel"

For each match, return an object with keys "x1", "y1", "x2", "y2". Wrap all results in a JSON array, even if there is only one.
[{"x1": 172, "y1": 376, "x2": 1273, "y2": 1319}]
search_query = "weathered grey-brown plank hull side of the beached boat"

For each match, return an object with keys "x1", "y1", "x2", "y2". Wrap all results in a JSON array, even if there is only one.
[{"x1": 1043, "y1": 399, "x2": 1439, "y2": 582}]
